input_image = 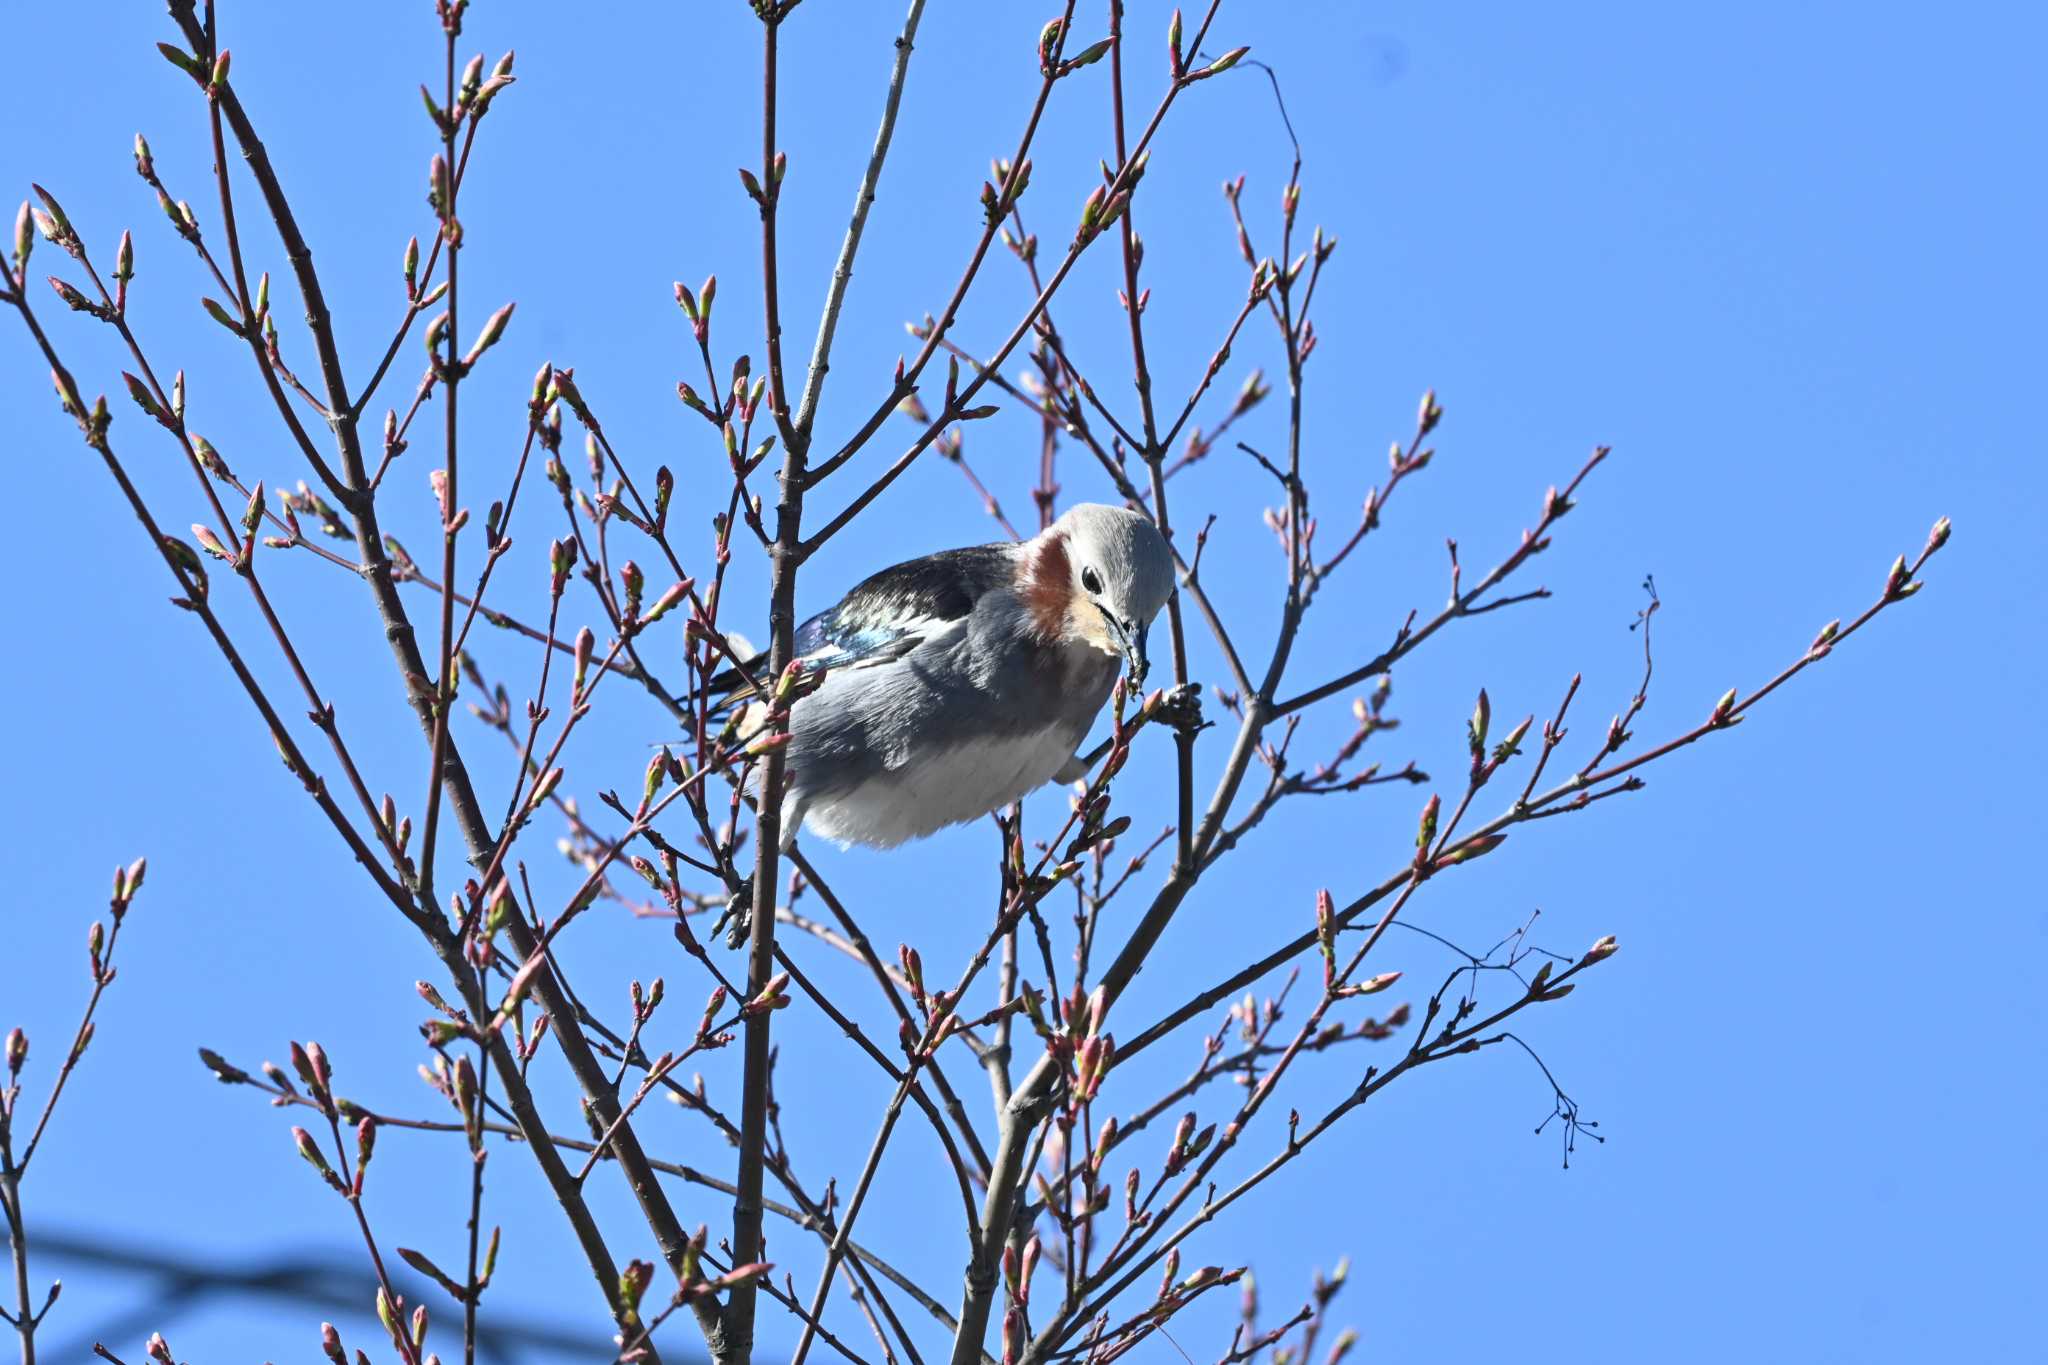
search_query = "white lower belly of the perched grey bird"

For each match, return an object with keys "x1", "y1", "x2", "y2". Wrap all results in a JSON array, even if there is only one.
[{"x1": 791, "y1": 729, "x2": 1075, "y2": 847}]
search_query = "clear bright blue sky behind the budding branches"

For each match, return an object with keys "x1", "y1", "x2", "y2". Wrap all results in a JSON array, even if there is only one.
[{"x1": 0, "y1": 0, "x2": 2048, "y2": 1361}]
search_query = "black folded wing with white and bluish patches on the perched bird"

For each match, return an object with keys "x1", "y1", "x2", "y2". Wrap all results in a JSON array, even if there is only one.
[{"x1": 711, "y1": 544, "x2": 1016, "y2": 692}]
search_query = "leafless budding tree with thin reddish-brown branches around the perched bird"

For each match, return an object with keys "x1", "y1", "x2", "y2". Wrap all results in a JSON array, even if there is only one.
[{"x1": 0, "y1": 0, "x2": 1948, "y2": 1365}]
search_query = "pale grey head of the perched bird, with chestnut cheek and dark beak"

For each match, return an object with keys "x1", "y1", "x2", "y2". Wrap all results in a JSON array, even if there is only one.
[{"x1": 1038, "y1": 503, "x2": 1174, "y2": 681}]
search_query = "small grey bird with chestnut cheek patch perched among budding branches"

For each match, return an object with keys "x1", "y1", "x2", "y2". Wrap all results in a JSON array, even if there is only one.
[{"x1": 713, "y1": 503, "x2": 1176, "y2": 851}]
